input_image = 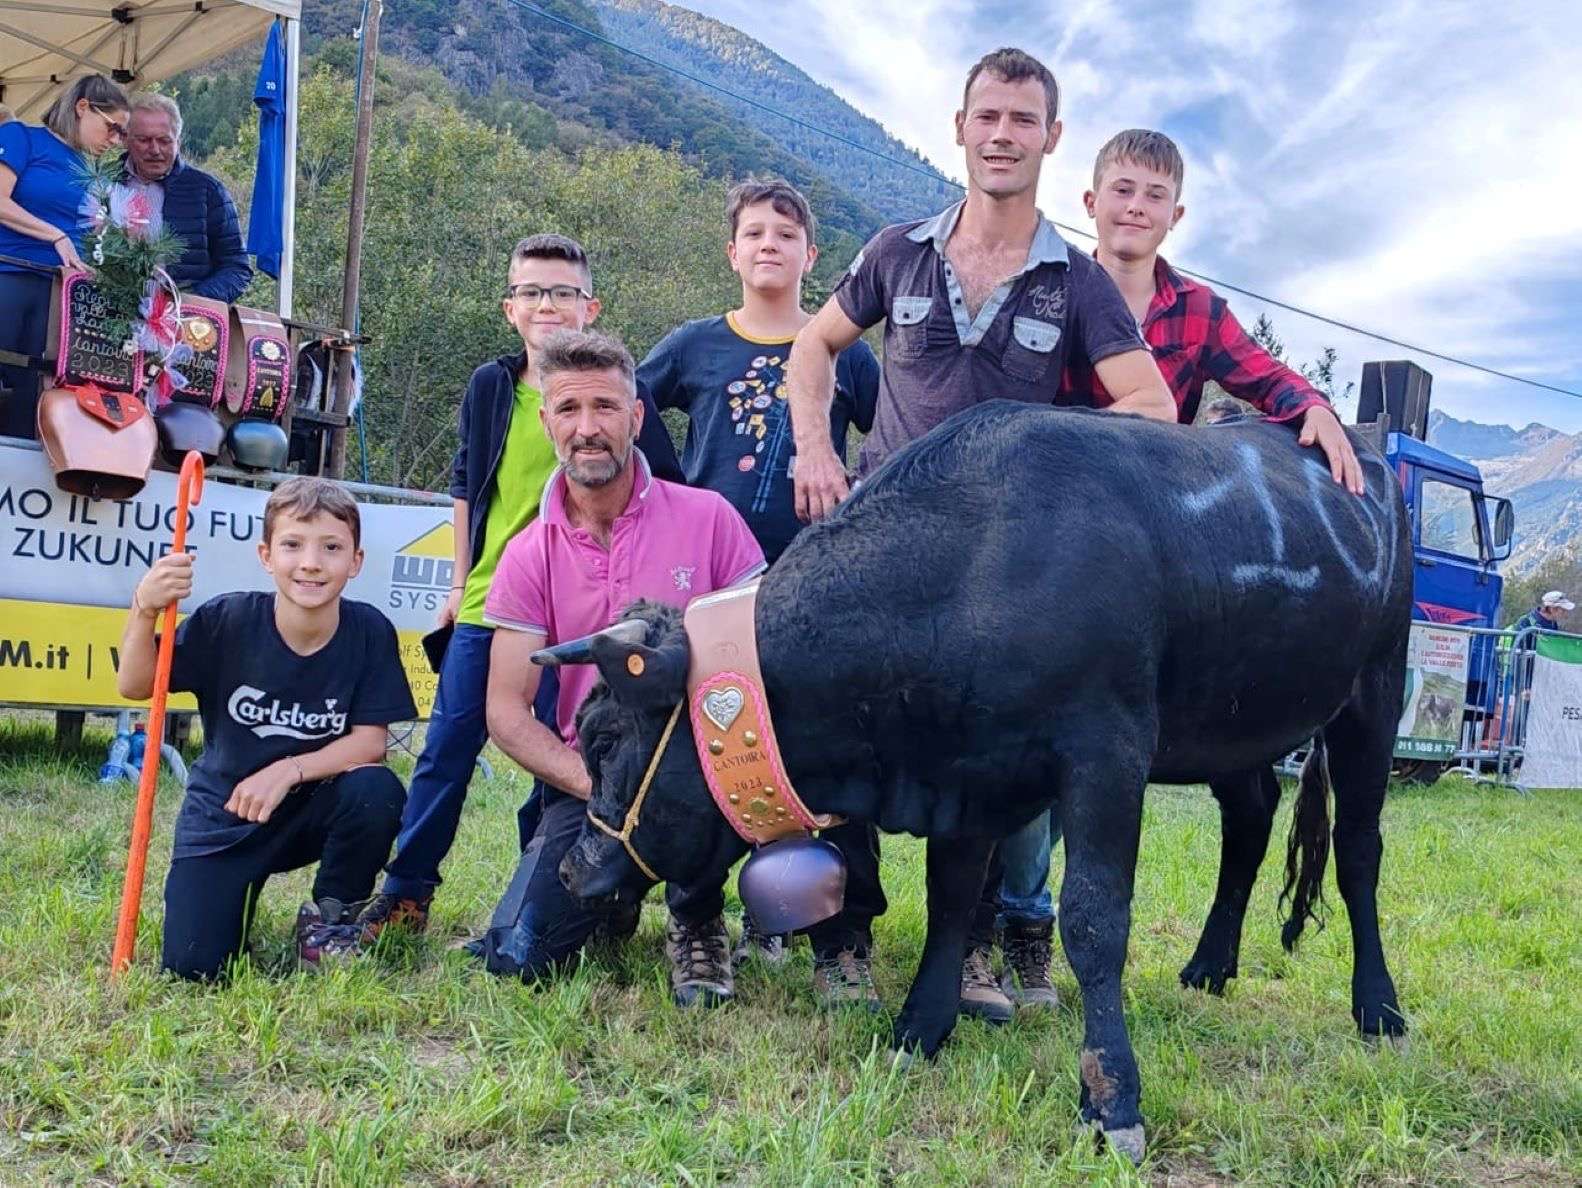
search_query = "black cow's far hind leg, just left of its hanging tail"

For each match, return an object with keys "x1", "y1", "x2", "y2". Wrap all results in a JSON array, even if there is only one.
[{"x1": 1182, "y1": 767, "x2": 1280, "y2": 993}]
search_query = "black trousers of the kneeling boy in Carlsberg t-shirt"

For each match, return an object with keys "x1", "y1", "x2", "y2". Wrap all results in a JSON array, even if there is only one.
[{"x1": 161, "y1": 767, "x2": 407, "y2": 979}]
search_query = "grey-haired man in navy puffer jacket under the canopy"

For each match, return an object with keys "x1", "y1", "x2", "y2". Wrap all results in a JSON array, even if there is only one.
[{"x1": 127, "y1": 92, "x2": 253, "y2": 302}]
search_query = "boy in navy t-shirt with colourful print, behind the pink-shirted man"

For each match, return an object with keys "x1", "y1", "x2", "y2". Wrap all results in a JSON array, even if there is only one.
[{"x1": 638, "y1": 179, "x2": 880, "y2": 565}]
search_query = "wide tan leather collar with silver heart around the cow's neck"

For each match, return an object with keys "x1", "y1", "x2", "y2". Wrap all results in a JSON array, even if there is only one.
[{"x1": 685, "y1": 581, "x2": 842, "y2": 845}]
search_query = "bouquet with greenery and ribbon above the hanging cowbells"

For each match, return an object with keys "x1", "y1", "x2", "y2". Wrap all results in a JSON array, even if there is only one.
[{"x1": 82, "y1": 153, "x2": 193, "y2": 403}]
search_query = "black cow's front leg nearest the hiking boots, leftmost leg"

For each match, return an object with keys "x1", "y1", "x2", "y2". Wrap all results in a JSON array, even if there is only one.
[{"x1": 894, "y1": 837, "x2": 993, "y2": 1057}]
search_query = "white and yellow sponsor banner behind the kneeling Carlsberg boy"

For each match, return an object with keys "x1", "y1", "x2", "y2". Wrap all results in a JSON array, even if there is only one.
[{"x1": 0, "y1": 449, "x2": 452, "y2": 717}]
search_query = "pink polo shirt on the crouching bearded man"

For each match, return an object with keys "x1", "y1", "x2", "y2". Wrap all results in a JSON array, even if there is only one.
[{"x1": 484, "y1": 451, "x2": 764, "y2": 747}]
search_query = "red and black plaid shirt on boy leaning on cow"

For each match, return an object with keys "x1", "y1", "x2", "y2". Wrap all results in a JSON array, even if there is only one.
[{"x1": 1055, "y1": 256, "x2": 1329, "y2": 424}]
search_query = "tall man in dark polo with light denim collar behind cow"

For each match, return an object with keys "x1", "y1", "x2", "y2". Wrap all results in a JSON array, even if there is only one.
[{"x1": 789, "y1": 49, "x2": 1175, "y2": 1022}]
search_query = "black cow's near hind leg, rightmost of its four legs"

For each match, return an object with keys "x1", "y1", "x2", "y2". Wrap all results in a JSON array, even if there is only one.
[{"x1": 1324, "y1": 664, "x2": 1406, "y2": 1036}]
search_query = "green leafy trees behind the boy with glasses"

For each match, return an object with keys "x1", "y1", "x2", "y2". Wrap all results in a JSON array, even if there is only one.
[{"x1": 206, "y1": 62, "x2": 737, "y2": 489}]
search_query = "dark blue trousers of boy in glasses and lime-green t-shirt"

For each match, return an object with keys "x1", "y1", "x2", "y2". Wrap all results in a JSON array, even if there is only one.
[{"x1": 384, "y1": 623, "x2": 560, "y2": 900}]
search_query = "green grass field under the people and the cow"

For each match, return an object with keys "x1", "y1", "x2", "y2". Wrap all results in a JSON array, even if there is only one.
[{"x1": 0, "y1": 721, "x2": 1582, "y2": 1185}]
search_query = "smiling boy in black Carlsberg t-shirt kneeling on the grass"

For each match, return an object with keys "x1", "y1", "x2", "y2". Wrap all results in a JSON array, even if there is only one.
[{"x1": 117, "y1": 478, "x2": 418, "y2": 979}]
